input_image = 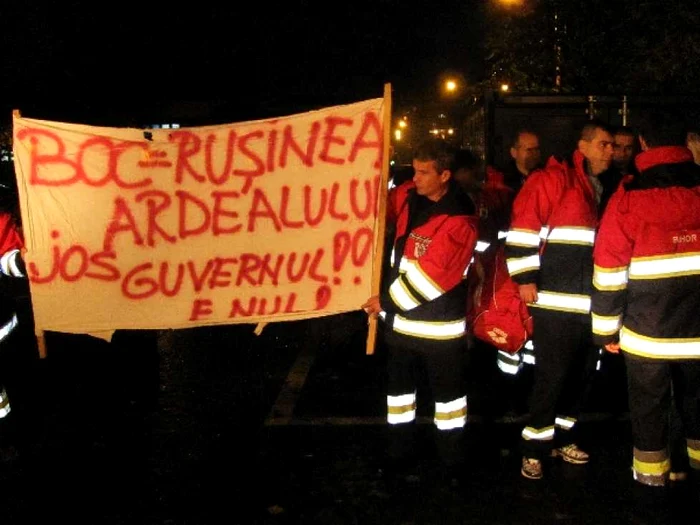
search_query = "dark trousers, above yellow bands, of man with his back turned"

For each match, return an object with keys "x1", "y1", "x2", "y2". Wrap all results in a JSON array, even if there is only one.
[{"x1": 625, "y1": 354, "x2": 700, "y2": 468}]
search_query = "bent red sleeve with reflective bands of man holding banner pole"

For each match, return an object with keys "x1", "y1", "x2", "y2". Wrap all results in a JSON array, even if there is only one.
[{"x1": 381, "y1": 217, "x2": 477, "y2": 313}]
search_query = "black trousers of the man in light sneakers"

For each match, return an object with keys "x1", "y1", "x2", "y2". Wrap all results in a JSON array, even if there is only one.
[{"x1": 521, "y1": 307, "x2": 598, "y2": 458}]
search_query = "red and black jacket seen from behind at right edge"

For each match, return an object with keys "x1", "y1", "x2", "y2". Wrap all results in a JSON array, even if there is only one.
[{"x1": 592, "y1": 146, "x2": 700, "y2": 359}]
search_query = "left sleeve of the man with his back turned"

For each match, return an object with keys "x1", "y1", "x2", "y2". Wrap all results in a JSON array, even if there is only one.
[{"x1": 591, "y1": 189, "x2": 638, "y2": 345}]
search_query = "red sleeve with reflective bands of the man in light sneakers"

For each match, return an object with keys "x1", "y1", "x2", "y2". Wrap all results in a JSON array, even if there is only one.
[{"x1": 505, "y1": 171, "x2": 563, "y2": 284}]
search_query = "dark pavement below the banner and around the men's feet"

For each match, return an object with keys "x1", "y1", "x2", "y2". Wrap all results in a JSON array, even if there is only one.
[{"x1": 0, "y1": 314, "x2": 697, "y2": 525}]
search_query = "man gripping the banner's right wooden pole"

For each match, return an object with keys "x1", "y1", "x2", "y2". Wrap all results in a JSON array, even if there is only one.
[{"x1": 362, "y1": 141, "x2": 477, "y2": 484}]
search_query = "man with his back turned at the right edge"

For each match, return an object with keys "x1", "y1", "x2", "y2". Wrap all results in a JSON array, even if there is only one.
[{"x1": 592, "y1": 109, "x2": 700, "y2": 504}]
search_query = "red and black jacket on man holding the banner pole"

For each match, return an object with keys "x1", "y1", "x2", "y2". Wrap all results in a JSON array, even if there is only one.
[{"x1": 380, "y1": 181, "x2": 478, "y2": 340}]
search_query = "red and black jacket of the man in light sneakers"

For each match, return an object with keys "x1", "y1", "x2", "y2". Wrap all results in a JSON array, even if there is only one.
[{"x1": 505, "y1": 151, "x2": 598, "y2": 321}]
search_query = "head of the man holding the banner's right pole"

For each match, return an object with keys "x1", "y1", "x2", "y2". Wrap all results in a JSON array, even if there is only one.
[{"x1": 413, "y1": 140, "x2": 455, "y2": 202}]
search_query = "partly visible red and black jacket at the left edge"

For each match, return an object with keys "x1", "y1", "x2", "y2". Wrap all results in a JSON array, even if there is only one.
[{"x1": 0, "y1": 212, "x2": 26, "y2": 341}]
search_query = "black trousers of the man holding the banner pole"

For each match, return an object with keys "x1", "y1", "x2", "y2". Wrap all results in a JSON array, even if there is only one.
[{"x1": 387, "y1": 336, "x2": 466, "y2": 466}]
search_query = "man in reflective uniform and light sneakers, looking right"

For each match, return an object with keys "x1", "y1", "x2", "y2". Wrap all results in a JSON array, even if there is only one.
[{"x1": 506, "y1": 121, "x2": 613, "y2": 479}]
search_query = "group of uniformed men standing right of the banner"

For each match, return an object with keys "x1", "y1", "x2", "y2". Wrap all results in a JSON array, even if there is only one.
[{"x1": 362, "y1": 112, "x2": 700, "y2": 512}]
